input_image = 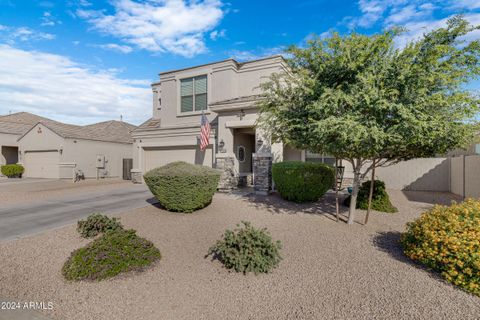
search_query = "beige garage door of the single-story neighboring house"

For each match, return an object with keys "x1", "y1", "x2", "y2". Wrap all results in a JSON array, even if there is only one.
[{"x1": 24, "y1": 151, "x2": 60, "y2": 179}]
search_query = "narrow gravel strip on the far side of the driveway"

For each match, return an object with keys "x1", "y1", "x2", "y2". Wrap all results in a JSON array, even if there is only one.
[{"x1": 0, "y1": 178, "x2": 132, "y2": 204}]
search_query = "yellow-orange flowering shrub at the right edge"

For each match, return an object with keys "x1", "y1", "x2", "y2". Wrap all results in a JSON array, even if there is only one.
[{"x1": 402, "y1": 199, "x2": 480, "y2": 296}]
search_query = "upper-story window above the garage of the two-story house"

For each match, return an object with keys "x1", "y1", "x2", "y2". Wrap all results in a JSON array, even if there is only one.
[{"x1": 180, "y1": 75, "x2": 207, "y2": 112}]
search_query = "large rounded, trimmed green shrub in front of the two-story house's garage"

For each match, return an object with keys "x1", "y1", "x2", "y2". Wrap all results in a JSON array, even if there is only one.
[{"x1": 143, "y1": 161, "x2": 220, "y2": 213}]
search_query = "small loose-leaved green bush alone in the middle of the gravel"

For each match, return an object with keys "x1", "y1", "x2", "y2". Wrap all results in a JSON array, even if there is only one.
[{"x1": 207, "y1": 221, "x2": 282, "y2": 274}]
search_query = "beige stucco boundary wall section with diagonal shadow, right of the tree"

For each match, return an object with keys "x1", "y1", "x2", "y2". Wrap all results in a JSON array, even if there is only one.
[{"x1": 376, "y1": 158, "x2": 450, "y2": 191}]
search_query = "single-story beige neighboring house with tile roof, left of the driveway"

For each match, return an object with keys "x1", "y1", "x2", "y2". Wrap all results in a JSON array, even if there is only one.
[{"x1": 0, "y1": 112, "x2": 136, "y2": 179}]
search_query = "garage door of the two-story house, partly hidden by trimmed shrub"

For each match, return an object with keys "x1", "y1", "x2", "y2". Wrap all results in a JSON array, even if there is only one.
[{"x1": 145, "y1": 147, "x2": 213, "y2": 171}]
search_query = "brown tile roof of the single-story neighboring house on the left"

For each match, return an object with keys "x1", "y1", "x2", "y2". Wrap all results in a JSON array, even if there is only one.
[{"x1": 0, "y1": 112, "x2": 136, "y2": 143}]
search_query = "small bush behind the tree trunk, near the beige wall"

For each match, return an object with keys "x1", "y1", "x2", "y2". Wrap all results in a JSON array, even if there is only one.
[{"x1": 344, "y1": 180, "x2": 398, "y2": 213}]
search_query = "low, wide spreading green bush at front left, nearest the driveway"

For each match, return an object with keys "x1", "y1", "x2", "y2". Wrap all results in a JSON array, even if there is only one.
[{"x1": 62, "y1": 229, "x2": 160, "y2": 281}]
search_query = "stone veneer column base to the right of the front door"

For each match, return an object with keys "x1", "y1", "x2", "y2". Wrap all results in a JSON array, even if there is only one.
[{"x1": 253, "y1": 153, "x2": 273, "y2": 195}]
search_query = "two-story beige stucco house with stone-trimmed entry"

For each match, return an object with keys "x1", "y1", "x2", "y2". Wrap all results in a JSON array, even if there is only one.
[{"x1": 132, "y1": 56, "x2": 305, "y2": 193}]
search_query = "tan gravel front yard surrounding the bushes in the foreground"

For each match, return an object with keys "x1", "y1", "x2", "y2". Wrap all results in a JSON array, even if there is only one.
[{"x1": 0, "y1": 191, "x2": 480, "y2": 320}]
